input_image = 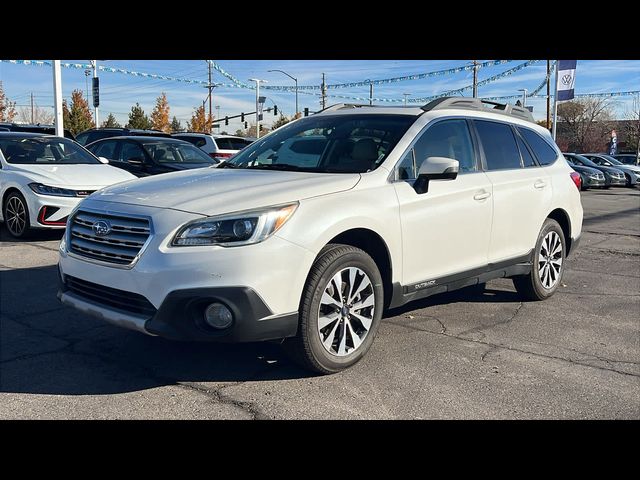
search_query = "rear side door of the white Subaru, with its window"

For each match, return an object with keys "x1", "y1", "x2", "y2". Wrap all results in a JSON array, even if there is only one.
[{"x1": 473, "y1": 120, "x2": 552, "y2": 263}]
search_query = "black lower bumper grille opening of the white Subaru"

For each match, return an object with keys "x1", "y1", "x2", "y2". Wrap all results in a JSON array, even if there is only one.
[{"x1": 64, "y1": 275, "x2": 156, "y2": 317}]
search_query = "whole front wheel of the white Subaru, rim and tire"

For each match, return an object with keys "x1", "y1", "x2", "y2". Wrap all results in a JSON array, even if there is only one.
[{"x1": 284, "y1": 244, "x2": 384, "y2": 374}]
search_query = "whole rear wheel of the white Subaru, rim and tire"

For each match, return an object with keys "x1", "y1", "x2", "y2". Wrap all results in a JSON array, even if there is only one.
[{"x1": 513, "y1": 218, "x2": 566, "y2": 300}]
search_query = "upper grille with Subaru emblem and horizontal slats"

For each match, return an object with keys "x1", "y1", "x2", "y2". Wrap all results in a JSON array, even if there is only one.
[{"x1": 69, "y1": 210, "x2": 151, "y2": 265}]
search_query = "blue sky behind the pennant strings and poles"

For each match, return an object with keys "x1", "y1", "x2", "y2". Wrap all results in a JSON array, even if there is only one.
[{"x1": 0, "y1": 60, "x2": 640, "y2": 133}]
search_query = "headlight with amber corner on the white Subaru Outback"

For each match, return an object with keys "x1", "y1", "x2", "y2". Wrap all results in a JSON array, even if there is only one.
[{"x1": 171, "y1": 202, "x2": 298, "y2": 247}]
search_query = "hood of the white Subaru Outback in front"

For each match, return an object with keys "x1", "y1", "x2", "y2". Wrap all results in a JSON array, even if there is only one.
[{"x1": 91, "y1": 168, "x2": 360, "y2": 215}]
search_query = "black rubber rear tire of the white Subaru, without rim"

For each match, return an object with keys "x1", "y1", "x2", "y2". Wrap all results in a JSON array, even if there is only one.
[{"x1": 512, "y1": 218, "x2": 567, "y2": 301}]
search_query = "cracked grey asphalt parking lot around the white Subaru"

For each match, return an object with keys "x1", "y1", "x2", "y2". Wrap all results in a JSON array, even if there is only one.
[{"x1": 0, "y1": 188, "x2": 640, "y2": 419}]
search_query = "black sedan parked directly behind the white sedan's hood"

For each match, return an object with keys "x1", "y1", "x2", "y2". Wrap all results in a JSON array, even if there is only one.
[{"x1": 85, "y1": 136, "x2": 216, "y2": 177}]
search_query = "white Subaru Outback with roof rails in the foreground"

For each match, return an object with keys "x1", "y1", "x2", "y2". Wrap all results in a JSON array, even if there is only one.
[{"x1": 58, "y1": 98, "x2": 582, "y2": 373}]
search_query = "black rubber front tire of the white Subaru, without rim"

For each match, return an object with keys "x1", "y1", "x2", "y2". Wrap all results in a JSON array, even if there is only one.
[{"x1": 283, "y1": 244, "x2": 384, "y2": 374}]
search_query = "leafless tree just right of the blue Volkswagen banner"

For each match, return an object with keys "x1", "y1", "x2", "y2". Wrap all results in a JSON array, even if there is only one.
[{"x1": 558, "y1": 97, "x2": 613, "y2": 152}]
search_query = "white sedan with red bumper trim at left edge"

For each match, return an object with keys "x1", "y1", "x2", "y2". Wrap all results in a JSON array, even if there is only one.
[{"x1": 0, "y1": 132, "x2": 136, "y2": 238}]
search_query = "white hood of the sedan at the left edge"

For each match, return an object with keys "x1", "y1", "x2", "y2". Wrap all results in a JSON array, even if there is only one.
[{"x1": 6, "y1": 163, "x2": 136, "y2": 190}]
